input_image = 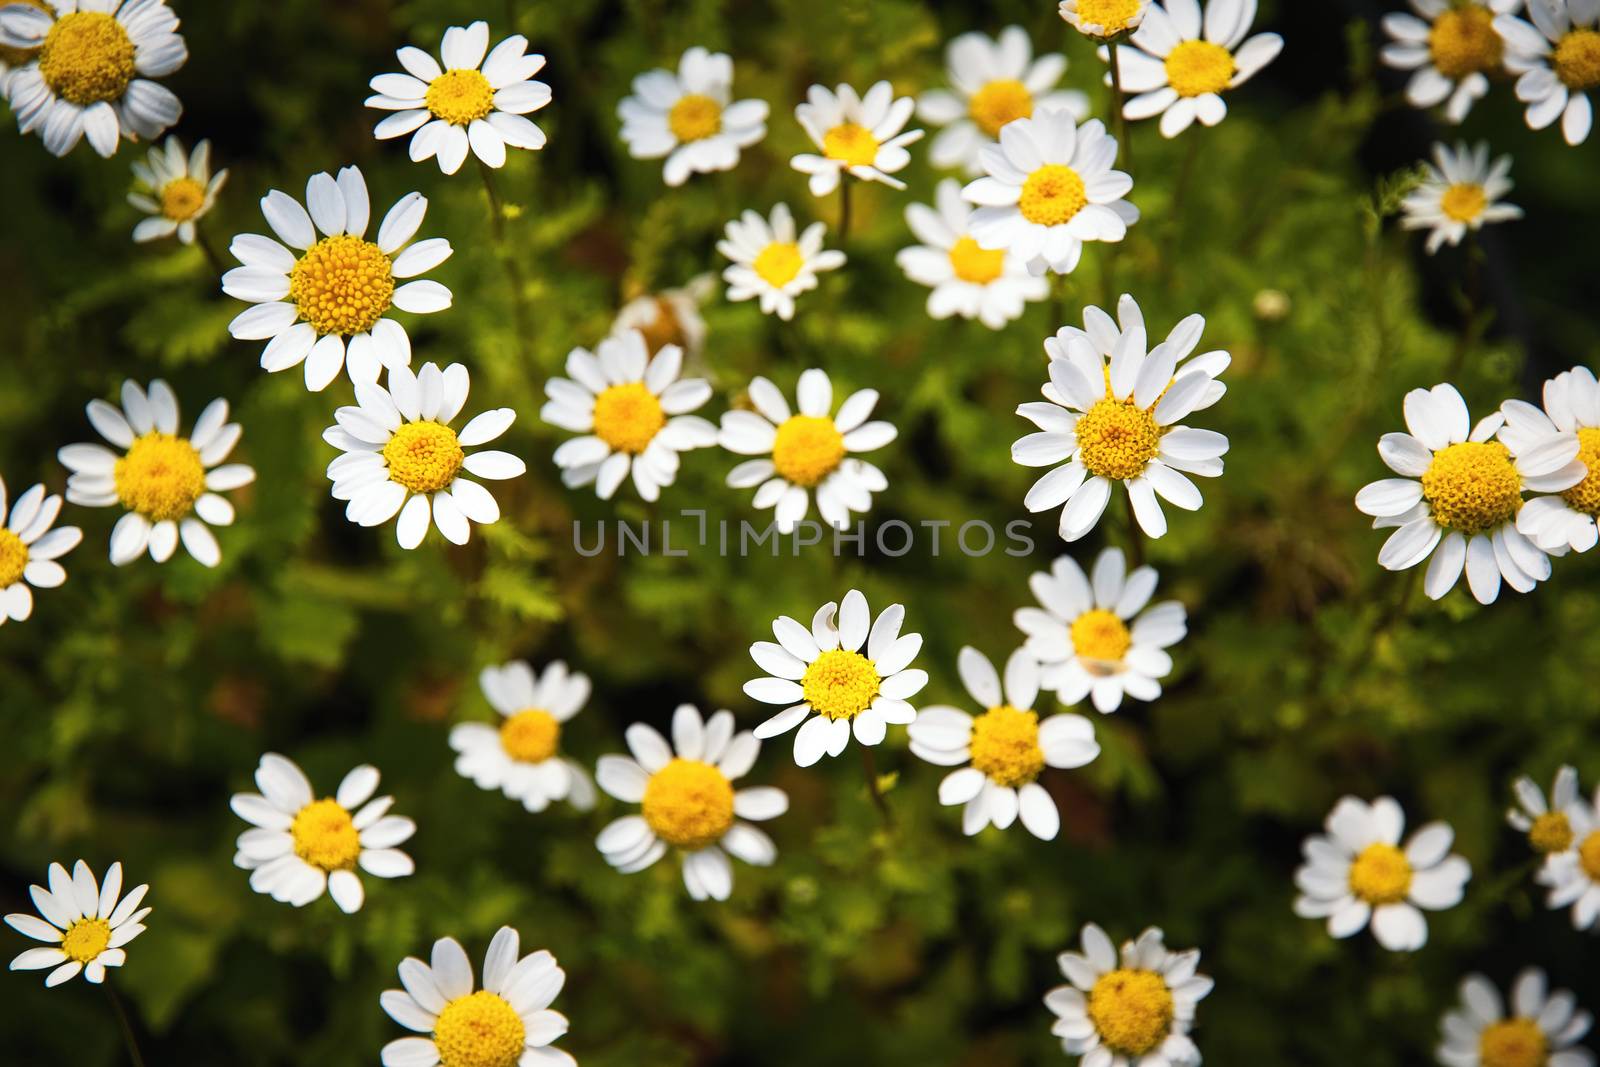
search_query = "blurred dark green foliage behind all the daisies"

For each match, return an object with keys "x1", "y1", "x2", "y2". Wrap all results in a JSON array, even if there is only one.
[{"x1": 0, "y1": 0, "x2": 1600, "y2": 1067}]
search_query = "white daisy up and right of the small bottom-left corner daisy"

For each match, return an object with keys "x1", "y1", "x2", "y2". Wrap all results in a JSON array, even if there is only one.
[{"x1": 229, "y1": 752, "x2": 416, "y2": 913}]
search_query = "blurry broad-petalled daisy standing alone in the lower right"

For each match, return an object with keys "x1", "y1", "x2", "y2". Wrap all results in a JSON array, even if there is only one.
[{"x1": 1294, "y1": 797, "x2": 1472, "y2": 952}]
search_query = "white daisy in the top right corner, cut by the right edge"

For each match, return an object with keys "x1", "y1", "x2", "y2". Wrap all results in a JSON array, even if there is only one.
[{"x1": 1494, "y1": 0, "x2": 1600, "y2": 144}]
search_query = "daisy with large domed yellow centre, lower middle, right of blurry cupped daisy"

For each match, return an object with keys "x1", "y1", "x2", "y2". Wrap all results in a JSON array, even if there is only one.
[{"x1": 595, "y1": 704, "x2": 789, "y2": 901}]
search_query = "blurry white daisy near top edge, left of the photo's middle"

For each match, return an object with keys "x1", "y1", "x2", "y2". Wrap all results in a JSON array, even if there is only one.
[{"x1": 616, "y1": 45, "x2": 768, "y2": 186}]
